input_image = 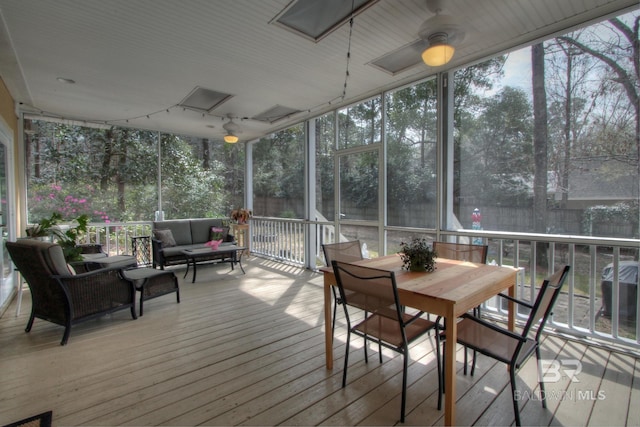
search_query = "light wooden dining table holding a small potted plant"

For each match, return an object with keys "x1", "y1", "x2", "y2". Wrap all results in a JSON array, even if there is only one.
[{"x1": 320, "y1": 254, "x2": 518, "y2": 425}]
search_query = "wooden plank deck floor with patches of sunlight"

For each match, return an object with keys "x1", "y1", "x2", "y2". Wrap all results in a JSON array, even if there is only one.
[{"x1": 0, "y1": 257, "x2": 640, "y2": 426}]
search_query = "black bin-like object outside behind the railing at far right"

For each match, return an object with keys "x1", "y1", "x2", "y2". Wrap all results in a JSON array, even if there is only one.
[{"x1": 600, "y1": 261, "x2": 640, "y2": 322}]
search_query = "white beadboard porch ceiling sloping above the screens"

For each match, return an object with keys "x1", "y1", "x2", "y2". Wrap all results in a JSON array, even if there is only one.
[{"x1": 0, "y1": 0, "x2": 637, "y2": 141}]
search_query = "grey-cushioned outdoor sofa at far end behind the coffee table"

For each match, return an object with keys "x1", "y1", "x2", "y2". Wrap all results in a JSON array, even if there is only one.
[{"x1": 151, "y1": 218, "x2": 235, "y2": 269}]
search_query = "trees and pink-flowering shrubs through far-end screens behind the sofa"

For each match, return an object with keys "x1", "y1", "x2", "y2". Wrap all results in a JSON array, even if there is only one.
[{"x1": 27, "y1": 121, "x2": 244, "y2": 222}]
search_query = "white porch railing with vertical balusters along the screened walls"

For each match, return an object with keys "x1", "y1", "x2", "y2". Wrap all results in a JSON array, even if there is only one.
[{"x1": 85, "y1": 217, "x2": 640, "y2": 349}]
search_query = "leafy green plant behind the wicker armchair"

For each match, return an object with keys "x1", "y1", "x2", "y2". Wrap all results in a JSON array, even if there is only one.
[{"x1": 26, "y1": 212, "x2": 89, "y2": 262}]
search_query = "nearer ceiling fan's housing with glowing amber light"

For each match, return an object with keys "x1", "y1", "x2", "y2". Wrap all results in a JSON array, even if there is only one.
[{"x1": 418, "y1": 0, "x2": 465, "y2": 67}]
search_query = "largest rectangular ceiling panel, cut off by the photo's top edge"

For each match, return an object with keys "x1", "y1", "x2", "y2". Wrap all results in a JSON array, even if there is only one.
[{"x1": 271, "y1": 0, "x2": 379, "y2": 42}]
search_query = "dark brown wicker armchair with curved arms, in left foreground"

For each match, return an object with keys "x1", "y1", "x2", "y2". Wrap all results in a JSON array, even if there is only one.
[{"x1": 6, "y1": 239, "x2": 137, "y2": 345}]
